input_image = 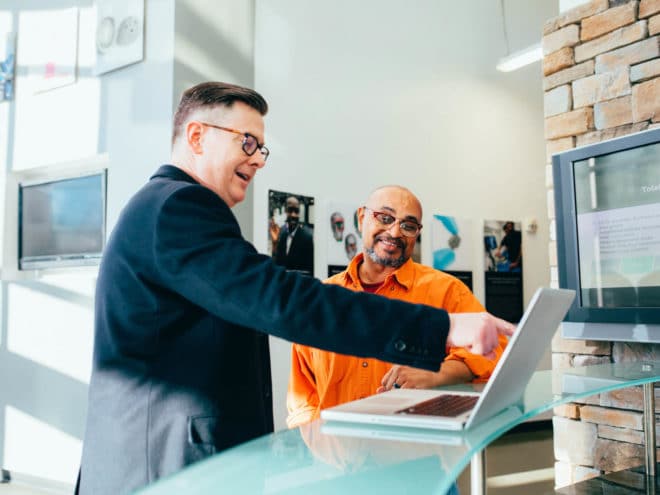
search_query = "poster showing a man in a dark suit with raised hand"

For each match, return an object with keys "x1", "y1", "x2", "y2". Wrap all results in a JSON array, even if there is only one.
[{"x1": 268, "y1": 190, "x2": 314, "y2": 276}]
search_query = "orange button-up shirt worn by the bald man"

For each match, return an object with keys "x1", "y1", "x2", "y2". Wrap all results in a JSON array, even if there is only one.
[{"x1": 287, "y1": 253, "x2": 507, "y2": 428}]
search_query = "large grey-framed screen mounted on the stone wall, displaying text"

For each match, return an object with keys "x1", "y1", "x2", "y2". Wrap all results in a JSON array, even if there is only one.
[{"x1": 552, "y1": 129, "x2": 660, "y2": 342}]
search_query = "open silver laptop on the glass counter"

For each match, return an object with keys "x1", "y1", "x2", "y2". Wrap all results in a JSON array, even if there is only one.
[{"x1": 321, "y1": 288, "x2": 575, "y2": 430}]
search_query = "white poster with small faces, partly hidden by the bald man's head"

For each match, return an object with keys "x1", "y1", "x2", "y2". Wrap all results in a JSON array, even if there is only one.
[{"x1": 323, "y1": 201, "x2": 362, "y2": 277}]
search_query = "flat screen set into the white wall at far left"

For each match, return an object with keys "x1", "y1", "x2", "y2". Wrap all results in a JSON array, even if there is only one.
[{"x1": 18, "y1": 170, "x2": 106, "y2": 270}]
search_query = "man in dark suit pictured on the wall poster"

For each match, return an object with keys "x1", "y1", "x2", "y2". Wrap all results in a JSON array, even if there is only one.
[{"x1": 271, "y1": 196, "x2": 314, "y2": 276}]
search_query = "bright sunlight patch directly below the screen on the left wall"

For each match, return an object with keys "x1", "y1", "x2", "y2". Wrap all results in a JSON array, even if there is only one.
[{"x1": 6, "y1": 278, "x2": 94, "y2": 384}]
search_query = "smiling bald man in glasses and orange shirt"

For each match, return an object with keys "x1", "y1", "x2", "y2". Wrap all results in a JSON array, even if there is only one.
[{"x1": 287, "y1": 186, "x2": 506, "y2": 428}]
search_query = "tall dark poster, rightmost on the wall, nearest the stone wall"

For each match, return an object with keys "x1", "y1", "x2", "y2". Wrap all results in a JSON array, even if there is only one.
[{"x1": 484, "y1": 220, "x2": 523, "y2": 323}]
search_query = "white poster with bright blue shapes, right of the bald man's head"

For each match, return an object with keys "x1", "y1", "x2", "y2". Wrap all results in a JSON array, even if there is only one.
[{"x1": 431, "y1": 214, "x2": 475, "y2": 290}]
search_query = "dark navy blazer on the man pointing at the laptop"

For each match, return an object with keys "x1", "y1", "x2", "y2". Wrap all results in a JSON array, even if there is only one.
[{"x1": 80, "y1": 165, "x2": 449, "y2": 495}]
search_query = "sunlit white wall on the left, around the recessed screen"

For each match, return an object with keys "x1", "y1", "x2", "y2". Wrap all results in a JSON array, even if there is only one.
[{"x1": 0, "y1": 0, "x2": 174, "y2": 483}]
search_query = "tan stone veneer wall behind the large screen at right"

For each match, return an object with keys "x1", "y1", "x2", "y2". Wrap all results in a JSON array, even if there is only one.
[{"x1": 543, "y1": 0, "x2": 660, "y2": 487}]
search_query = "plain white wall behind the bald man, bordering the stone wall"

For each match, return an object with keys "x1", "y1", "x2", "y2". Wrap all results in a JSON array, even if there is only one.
[{"x1": 254, "y1": 0, "x2": 556, "y2": 427}]
